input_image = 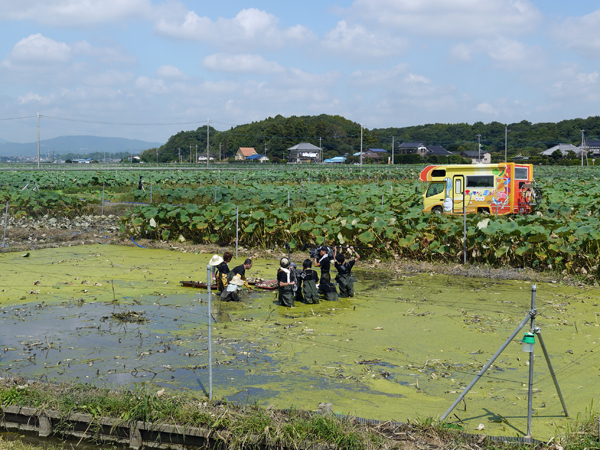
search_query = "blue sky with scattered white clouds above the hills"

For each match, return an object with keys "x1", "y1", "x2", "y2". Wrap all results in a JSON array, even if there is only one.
[{"x1": 0, "y1": 0, "x2": 600, "y2": 142}]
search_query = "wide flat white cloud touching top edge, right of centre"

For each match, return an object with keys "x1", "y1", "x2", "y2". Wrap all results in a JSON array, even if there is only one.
[{"x1": 349, "y1": 0, "x2": 541, "y2": 39}]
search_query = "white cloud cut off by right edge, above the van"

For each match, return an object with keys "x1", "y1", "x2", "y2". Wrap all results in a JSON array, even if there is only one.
[{"x1": 550, "y1": 9, "x2": 600, "y2": 57}]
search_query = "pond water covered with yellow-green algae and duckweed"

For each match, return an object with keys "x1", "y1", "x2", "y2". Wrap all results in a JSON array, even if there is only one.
[{"x1": 0, "y1": 245, "x2": 600, "y2": 438}]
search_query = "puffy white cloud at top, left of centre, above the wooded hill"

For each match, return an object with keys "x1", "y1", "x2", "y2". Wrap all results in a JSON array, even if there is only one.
[{"x1": 154, "y1": 8, "x2": 314, "y2": 51}]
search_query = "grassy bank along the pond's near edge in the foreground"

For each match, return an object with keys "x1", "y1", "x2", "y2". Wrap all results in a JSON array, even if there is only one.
[{"x1": 0, "y1": 379, "x2": 600, "y2": 450}]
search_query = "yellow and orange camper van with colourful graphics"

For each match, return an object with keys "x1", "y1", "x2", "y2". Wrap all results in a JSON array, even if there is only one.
[{"x1": 420, "y1": 162, "x2": 541, "y2": 214}]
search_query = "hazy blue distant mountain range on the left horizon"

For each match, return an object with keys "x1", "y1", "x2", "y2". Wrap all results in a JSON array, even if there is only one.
[{"x1": 0, "y1": 136, "x2": 163, "y2": 157}]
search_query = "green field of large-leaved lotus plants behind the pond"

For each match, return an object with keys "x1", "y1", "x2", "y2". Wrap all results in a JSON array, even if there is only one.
[{"x1": 0, "y1": 166, "x2": 600, "y2": 279}]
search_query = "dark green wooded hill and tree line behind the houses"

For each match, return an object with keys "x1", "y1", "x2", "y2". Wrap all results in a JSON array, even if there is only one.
[{"x1": 141, "y1": 114, "x2": 600, "y2": 163}]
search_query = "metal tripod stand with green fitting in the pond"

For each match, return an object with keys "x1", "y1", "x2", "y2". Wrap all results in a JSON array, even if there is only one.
[{"x1": 440, "y1": 284, "x2": 569, "y2": 438}]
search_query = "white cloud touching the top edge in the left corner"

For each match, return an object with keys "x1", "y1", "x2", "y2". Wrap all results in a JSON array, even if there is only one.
[{"x1": 0, "y1": 0, "x2": 153, "y2": 27}]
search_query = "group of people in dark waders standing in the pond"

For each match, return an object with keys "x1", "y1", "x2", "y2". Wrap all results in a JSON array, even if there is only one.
[{"x1": 209, "y1": 247, "x2": 360, "y2": 307}]
